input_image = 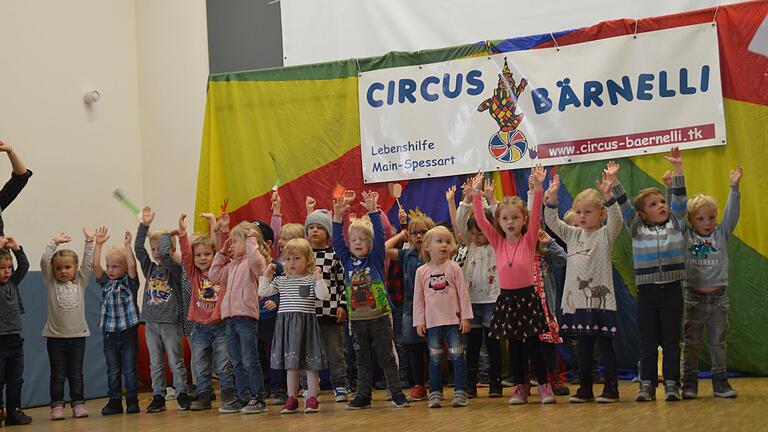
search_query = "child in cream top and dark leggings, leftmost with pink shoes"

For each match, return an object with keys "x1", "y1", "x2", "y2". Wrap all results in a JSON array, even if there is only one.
[{"x1": 40, "y1": 228, "x2": 96, "y2": 420}]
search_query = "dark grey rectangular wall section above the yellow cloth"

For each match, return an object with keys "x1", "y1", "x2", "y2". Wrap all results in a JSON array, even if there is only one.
[{"x1": 206, "y1": 0, "x2": 283, "y2": 74}]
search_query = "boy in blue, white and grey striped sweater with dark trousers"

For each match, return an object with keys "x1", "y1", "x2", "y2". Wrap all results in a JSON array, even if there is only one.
[{"x1": 612, "y1": 147, "x2": 687, "y2": 402}]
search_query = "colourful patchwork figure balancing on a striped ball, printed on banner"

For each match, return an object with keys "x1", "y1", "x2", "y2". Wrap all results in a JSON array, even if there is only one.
[{"x1": 477, "y1": 57, "x2": 536, "y2": 163}]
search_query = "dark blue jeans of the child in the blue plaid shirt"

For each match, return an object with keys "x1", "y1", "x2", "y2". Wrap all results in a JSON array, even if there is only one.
[{"x1": 103, "y1": 326, "x2": 139, "y2": 399}]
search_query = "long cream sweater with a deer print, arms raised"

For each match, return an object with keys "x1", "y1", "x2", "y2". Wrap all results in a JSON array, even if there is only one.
[{"x1": 544, "y1": 199, "x2": 622, "y2": 333}]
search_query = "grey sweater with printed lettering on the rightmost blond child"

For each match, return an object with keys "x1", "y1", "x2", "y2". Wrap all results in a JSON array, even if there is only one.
[{"x1": 683, "y1": 186, "x2": 741, "y2": 288}]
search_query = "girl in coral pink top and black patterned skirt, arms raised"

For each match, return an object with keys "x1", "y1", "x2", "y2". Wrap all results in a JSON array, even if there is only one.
[{"x1": 472, "y1": 165, "x2": 556, "y2": 405}]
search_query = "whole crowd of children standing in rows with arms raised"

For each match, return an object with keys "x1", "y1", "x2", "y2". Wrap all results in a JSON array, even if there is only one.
[{"x1": 0, "y1": 141, "x2": 741, "y2": 425}]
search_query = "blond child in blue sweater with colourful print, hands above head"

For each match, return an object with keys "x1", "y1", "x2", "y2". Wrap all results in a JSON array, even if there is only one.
[{"x1": 332, "y1": 191, "x2": 409, "y2": 409}]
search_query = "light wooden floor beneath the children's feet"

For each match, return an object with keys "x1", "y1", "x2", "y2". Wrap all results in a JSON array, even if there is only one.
[{"x1": 16, "y1": 378, "x2": 768, "y2": 432}]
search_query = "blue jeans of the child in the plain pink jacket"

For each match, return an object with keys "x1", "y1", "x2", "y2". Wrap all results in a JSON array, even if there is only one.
[{"x1": 224, "y1": 317, "x2": 266, "y2": 401}]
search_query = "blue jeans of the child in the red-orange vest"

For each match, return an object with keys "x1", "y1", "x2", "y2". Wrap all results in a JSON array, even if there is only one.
[{"x1": 189, "y1": 322, "x2": 234, "y2": 393}]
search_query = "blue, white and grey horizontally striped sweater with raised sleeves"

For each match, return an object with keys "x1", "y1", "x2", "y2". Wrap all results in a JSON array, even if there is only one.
[{"x1": 612, "y1": 176, "x2": 688, "y2": 286}]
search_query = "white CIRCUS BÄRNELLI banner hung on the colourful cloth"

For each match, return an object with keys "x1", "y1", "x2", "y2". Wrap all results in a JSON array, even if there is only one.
[{"x1": 359, "y1": 24, "x2": 725, "y2": 183}]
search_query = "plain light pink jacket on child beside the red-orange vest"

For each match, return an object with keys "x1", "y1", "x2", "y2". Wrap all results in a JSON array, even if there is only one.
[{"x1": 208, "y1": 237, "x2": 267, "y2": 319}]
